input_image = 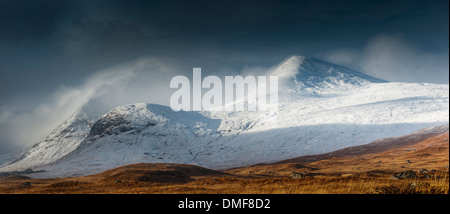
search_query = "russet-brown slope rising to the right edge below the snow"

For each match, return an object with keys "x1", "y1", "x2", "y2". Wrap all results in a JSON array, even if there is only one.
[{"x1": 226, "y1": 124, "x2": 449, "y2": 177}]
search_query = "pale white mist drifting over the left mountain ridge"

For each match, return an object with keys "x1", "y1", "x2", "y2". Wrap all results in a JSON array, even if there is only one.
[{"x1": 0, "y1": 59, "x2": 178, "y2": 154}]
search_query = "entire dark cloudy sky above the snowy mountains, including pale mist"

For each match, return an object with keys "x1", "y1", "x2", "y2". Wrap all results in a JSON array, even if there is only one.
[{"x1": 0, "y1": 0, "x2": 449, "y2": 153}]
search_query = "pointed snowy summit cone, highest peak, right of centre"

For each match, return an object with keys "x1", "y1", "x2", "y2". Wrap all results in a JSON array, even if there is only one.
[{"x1": 272, "y1": 56, "x2": 385, "y2": 94}]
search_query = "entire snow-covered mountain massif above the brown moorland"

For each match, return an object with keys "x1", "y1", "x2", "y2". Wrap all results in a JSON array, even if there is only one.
[{"x1": 0, "y1": 56, "x2": 449, "y2": 177}]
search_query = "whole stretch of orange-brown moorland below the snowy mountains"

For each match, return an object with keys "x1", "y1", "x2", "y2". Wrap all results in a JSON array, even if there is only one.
[{"x1": 0, "y1": 130, "x2": 449, "y2": 194}]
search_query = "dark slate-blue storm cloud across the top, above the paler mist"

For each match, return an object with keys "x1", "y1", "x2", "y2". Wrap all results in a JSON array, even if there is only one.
[{"x1": 0, "y1": 0, "x2": 448, "y2": 79}]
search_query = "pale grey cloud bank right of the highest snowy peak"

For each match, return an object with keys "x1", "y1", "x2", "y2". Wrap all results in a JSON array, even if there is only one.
[{"x1": 359, "y1": 34, "x2": 449, "y2": 83}]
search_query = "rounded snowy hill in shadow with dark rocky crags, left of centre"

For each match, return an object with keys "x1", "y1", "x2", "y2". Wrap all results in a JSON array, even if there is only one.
[{"x1": 36, "y1": 103, "x2": 220, "y2": 175}]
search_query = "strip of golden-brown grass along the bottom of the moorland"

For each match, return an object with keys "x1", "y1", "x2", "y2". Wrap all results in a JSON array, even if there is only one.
[{"x1": 0, "y1": 169, "x2": 449, "y2": 194}]
